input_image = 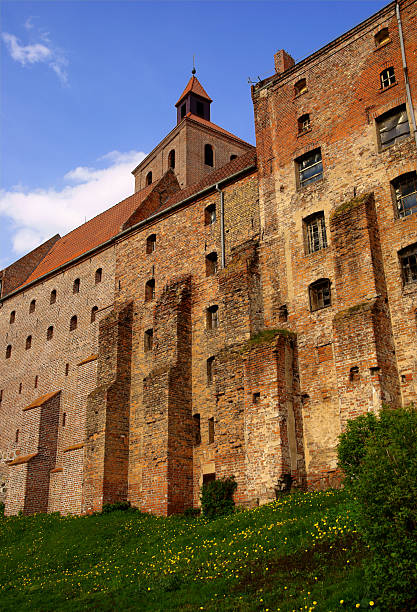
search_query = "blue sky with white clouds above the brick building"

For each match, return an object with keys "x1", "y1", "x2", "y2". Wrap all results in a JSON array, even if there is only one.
[{"x1": 0, "y1": 0, "x2": 387, "y2": 269}]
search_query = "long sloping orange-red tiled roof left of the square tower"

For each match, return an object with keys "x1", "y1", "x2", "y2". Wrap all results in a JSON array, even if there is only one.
[{"x1": 21, "y1": 185, "x2": 154, "y2": 287}]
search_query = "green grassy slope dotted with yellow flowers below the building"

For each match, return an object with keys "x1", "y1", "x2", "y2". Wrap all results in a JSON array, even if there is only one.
[{"x1": 0, "y1": 491, "x2": 378, "y2": 612}]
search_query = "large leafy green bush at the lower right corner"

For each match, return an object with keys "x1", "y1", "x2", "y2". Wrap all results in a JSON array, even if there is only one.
[{"x1": 340, "y1": 408, "x2": 417, "y2": 610}]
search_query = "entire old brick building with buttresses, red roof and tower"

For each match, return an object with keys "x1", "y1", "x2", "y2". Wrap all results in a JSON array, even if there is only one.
[{"x1": 0, "y1": 0, "x2": 417, "y2": 514}]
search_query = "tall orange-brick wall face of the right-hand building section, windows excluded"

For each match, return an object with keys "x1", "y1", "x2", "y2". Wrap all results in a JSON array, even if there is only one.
[{"x1": 253, "y1": 1, "x2": 417, "y2": 487}]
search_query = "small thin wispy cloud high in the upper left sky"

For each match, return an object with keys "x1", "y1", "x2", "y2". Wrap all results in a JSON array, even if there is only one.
[{"x1": 2, "y1": 24, "x2": 68, "y2": 85}]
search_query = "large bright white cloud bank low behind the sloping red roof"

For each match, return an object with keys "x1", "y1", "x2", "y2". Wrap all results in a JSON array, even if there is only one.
[{"x1": 0, "y1": 151, "x2": 145, "y2": 256}]
